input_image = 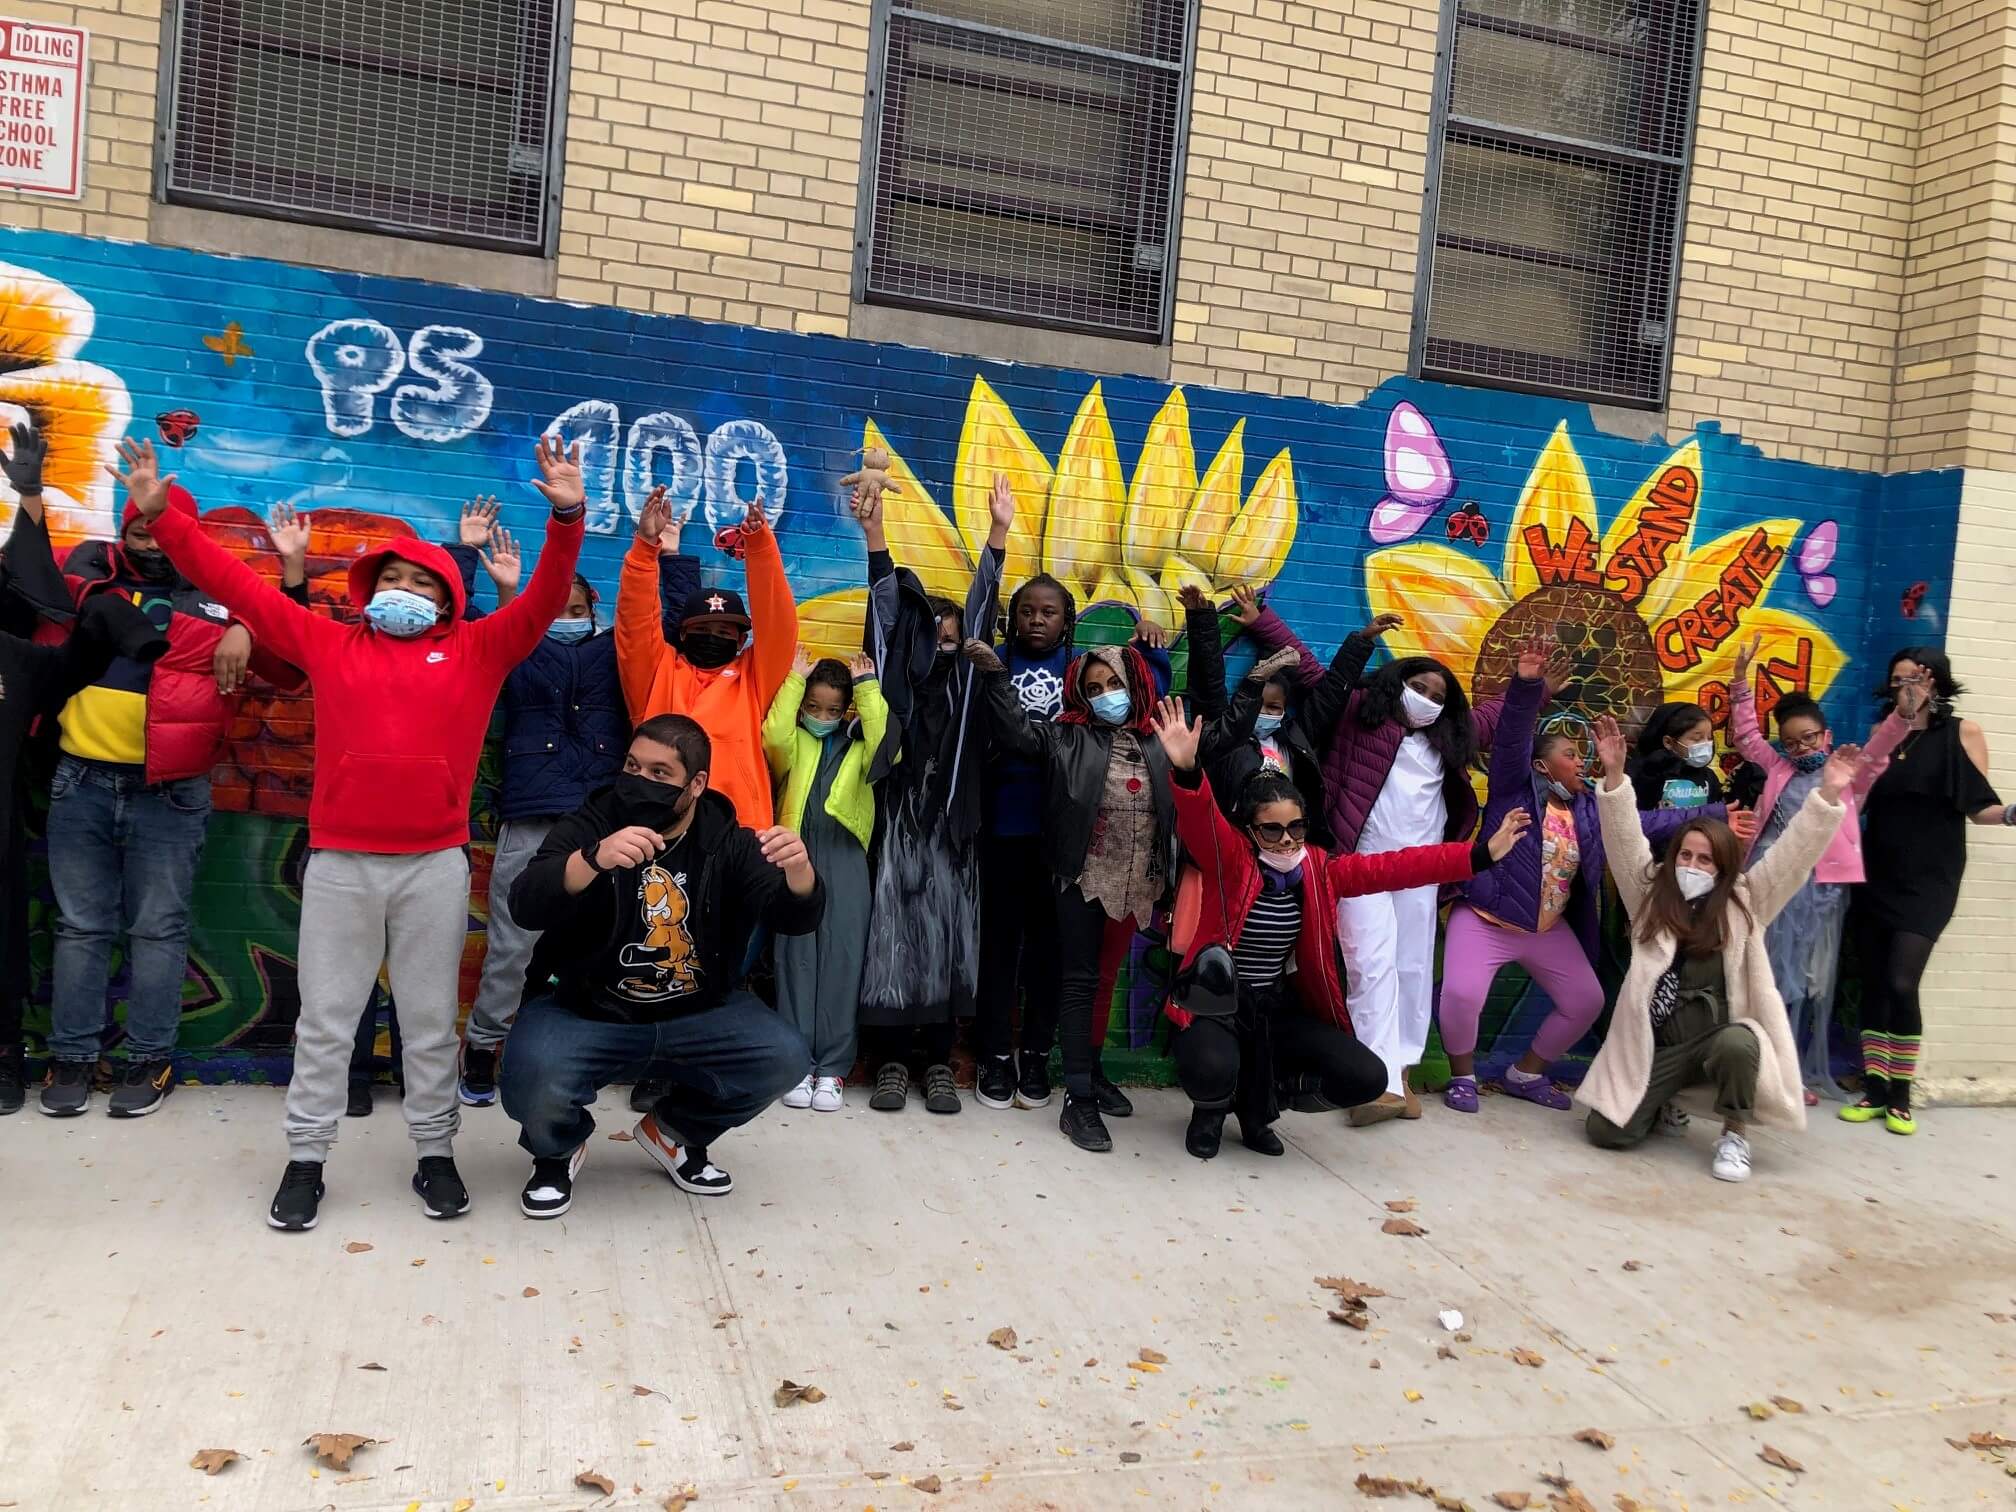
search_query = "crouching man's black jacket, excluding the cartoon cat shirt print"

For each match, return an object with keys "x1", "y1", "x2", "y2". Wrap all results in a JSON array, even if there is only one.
[{"x1": 510, "y1": 786, "x2": 827, "y2": 1024}]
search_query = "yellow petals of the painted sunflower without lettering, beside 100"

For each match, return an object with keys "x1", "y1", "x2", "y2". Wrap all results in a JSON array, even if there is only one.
[{"x1": 798, "y1": 377, "x2": 1296, "y2": 655}]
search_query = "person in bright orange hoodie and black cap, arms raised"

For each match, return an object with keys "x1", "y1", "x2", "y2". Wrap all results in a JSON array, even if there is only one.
[{"x1": 617, "y1": 498, "x2": 798, "y2": 829}]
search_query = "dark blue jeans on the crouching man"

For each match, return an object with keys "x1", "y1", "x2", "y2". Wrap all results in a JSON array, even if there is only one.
[{"x1": 498, "y1": 992, "x2": 812, "y2": 1157}]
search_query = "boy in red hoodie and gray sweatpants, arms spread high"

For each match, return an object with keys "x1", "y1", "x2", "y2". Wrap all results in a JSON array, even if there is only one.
[{"x1": 113, "y1": 429, "x2": 583, "y2": 1230}]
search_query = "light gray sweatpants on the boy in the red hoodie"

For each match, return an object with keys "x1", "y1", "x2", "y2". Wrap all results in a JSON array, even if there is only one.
[{"x1": 286, "y1": 847, "x2": 470, "y2": 1161}]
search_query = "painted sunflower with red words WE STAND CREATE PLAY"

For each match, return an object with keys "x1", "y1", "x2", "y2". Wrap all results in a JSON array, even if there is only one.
[{"x1": 1365, "y1": 423, "x2": 1847, "y2": 732}]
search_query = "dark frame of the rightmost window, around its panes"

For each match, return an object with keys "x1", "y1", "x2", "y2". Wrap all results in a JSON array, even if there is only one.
[{"x1": 1409, "y1": 0, "x2": 1708, "y2": 409}]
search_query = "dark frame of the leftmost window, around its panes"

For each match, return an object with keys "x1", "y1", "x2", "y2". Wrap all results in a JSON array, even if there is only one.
[{"x1": 155, "y1": 0, "x2": 573, "y2": 258}]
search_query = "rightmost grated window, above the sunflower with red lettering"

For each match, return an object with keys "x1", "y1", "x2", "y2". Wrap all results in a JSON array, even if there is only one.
[{"x1": 1413, "y1": 0, "x2": 1702, "y2": 407}]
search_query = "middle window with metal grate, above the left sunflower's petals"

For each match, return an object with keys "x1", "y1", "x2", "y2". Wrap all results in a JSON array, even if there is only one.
[{"x1": 859, "y1": 0, "x2": 1193, "y2": 341}]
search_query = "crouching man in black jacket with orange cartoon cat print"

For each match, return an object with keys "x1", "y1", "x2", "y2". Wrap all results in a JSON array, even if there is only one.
[{"x1": 498, "y1": 714, "x2": 827, "y2": 1218}]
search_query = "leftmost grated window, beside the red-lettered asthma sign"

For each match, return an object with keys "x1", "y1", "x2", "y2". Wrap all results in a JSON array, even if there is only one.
[{"x1": 161, "y1": 0, "x2": 566, "y2": 252}]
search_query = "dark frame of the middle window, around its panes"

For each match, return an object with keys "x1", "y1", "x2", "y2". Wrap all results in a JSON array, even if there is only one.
[{"x1": 853, "y1": 0, "x2": 1202, "y2": 345}]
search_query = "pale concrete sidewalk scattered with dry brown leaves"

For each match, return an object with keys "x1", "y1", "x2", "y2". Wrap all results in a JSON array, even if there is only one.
[{"x1": 0, "y1": 1087, "x2": 2016, "y2": 1512}]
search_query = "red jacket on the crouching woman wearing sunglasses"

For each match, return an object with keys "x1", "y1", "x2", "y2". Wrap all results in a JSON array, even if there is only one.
[{"x1": 1163, "y1": 768, "x2": 1472, "y2": 1030}]
